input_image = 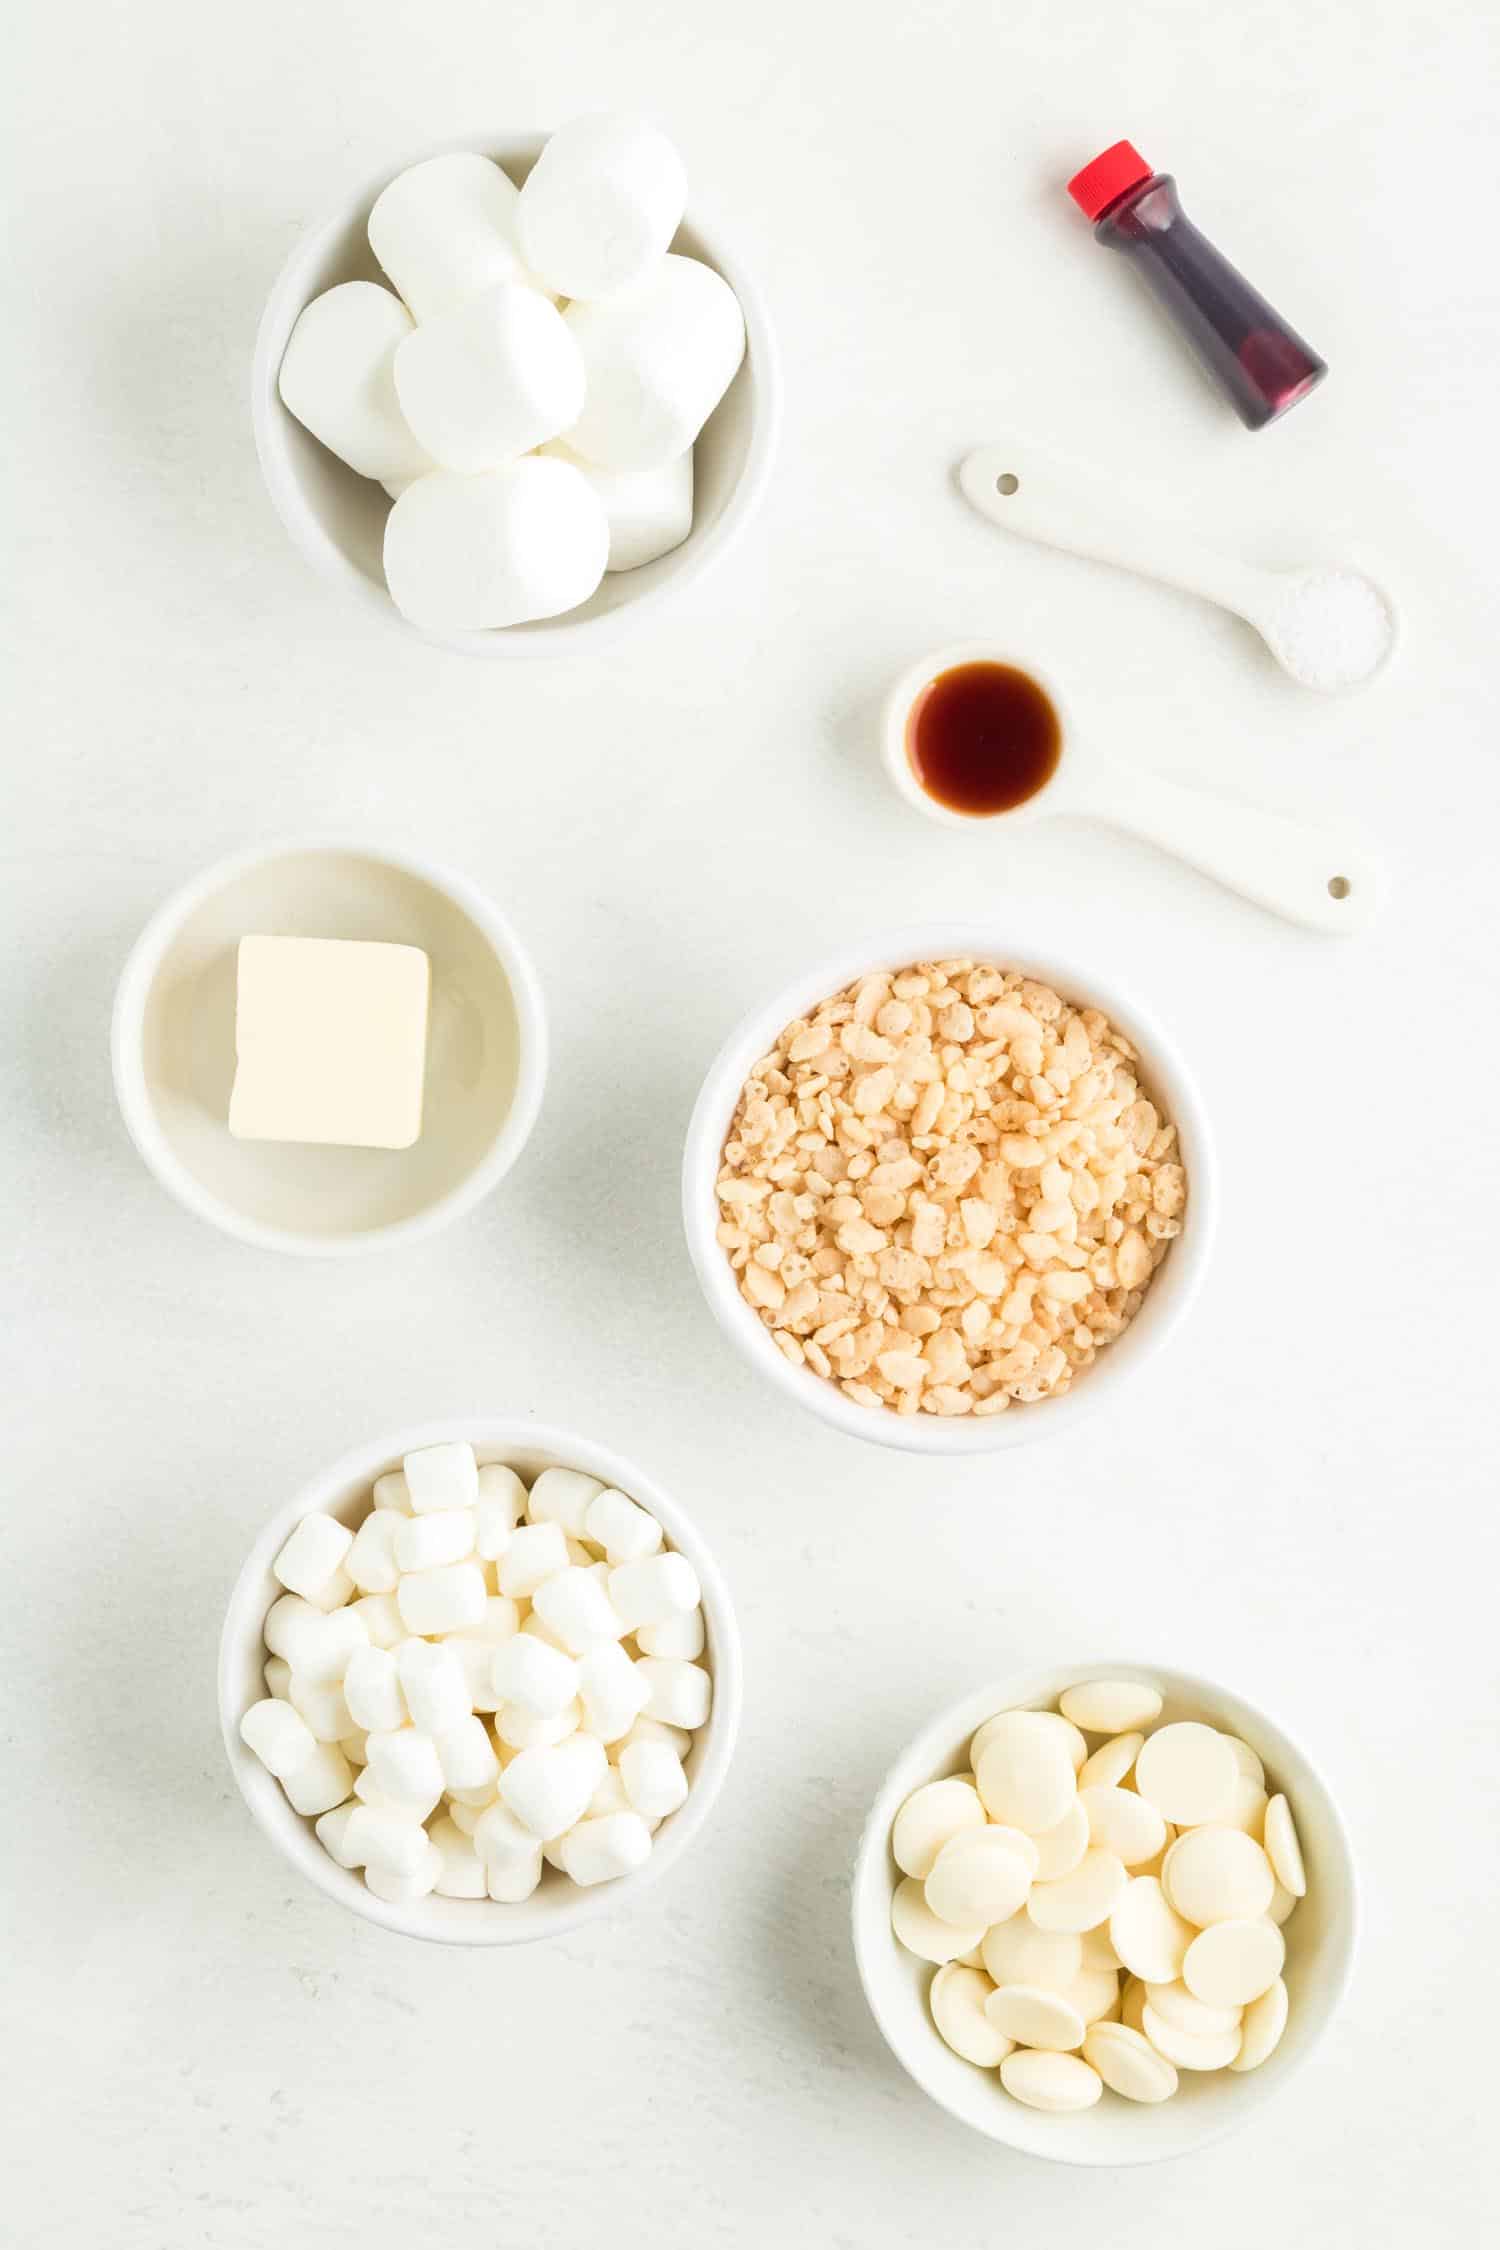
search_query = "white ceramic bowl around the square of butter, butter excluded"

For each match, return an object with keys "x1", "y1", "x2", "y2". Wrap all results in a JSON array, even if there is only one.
[{"x1": 110, "y1": 837, "x2": 546, "y2": 1258}]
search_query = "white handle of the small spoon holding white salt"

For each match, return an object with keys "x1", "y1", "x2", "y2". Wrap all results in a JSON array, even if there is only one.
[{"x1": 958, "y1": 439, "x2": 1264, "y2": 623}]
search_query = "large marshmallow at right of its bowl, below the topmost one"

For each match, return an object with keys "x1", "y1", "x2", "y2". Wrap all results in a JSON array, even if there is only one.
[{"x1": 562, "y1": 257, "x2": 744, "y2": 468}]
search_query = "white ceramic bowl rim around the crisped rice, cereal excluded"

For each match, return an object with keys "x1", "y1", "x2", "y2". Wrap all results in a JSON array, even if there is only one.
[{"x1": 681, "y1": 925, "x2": 1219, "y2": 1454}]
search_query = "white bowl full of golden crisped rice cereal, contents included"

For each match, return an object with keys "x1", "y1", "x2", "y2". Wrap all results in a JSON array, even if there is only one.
[{"x1": 681, "y1": 927, "x2": 1217, "y2": 1454}]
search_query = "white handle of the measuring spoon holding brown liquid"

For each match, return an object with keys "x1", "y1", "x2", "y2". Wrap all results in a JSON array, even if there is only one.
[{"x1": 1068, "y1": 758, "x2": 1385, "y2": 936}]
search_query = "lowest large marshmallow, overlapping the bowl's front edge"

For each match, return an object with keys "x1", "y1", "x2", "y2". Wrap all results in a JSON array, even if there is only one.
[{"x1": 385, "y1": 455, "x2": 609, "y2": 632}]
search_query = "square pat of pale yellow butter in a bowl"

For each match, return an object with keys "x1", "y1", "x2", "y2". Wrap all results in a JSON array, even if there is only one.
[{"x1": 229, "y1": 936, "x2": 430, "y2": 1148}]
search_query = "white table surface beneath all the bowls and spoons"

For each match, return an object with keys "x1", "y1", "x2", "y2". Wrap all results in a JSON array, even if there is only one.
[{"x1": 0, "y1": 0, "x2": 1500, "y2": 2250}]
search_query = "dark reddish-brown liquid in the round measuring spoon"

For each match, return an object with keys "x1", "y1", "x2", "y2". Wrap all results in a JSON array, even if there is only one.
[{"x1": 906, "y1": 664, "x2": 1061, "y2": 817}]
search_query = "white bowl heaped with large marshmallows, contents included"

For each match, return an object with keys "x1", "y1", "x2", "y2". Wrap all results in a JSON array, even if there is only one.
[{"x1": 252, "y1": 113, "x2": 780, "y2": 657}]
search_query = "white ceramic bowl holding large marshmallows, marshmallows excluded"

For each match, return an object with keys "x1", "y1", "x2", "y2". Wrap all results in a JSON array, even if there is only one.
[{"x1": 250, "y1": 133, "x2": 780, "y2": 657}]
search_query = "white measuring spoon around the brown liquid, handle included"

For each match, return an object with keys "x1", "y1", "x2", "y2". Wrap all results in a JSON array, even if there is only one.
[{"x1": 882, "y1": 641, "x2": 1385, "y2": 936}]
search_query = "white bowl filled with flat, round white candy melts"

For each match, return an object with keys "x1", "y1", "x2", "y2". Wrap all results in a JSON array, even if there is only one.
[{"x1": 852, "y1": 1663, "x2": 1356, "y2": 2165}]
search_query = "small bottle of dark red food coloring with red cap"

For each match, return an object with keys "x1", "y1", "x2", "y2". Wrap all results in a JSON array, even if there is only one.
[{"x1": 1068, "y1": 142, "x2": 1327, "y2": 430}]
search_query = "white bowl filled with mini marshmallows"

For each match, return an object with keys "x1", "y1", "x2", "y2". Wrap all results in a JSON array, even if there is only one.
[{"x1": 218, "y1": 1418, "x2": 740, "y2": 1946}]
